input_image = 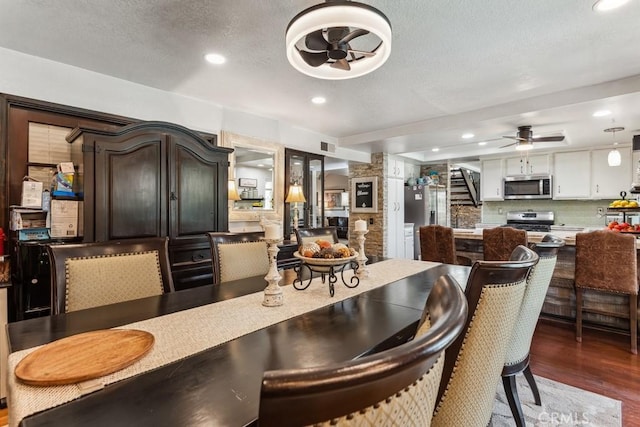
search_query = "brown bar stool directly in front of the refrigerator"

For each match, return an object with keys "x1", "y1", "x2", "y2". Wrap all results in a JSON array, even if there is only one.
[{"x1": 418, "y1": 224, "x2": 471, "y2": 265}]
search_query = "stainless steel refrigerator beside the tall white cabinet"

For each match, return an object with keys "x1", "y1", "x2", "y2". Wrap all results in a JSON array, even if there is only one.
[{"x1": 404, "y1": 185, "x2": 447, "y2": 259}]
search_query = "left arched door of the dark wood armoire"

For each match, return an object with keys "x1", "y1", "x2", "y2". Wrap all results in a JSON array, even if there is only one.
[{"x1": 95, "y1": 138, "x2": 167, "y2": 241}]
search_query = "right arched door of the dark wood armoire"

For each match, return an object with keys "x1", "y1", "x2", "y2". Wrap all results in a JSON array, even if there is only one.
[{"x1": 170, "y1": 144, "x2": 226, "y2": 238}]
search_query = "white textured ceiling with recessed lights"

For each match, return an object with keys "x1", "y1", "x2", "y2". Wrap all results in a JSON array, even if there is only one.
[{"x1": 0, "y1": 0, "x2": 640, "y2": 160}]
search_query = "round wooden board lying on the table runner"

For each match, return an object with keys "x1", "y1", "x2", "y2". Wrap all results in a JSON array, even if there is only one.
[{"x1": 15, "y1": 329, "x2": 154, "y2": 386}]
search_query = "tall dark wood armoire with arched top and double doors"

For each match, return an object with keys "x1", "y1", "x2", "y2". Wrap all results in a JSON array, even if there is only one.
[{"x1": 67, "y1": 122, "x2": 233, "y2": 290}]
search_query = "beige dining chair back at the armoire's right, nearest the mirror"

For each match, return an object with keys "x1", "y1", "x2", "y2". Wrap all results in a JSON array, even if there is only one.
[{"x1": 207, "y1": 231, "x2": 269, "y2": 284}]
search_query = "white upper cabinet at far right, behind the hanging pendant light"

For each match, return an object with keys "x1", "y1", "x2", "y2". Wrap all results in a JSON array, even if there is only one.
[{"x1": 591, "y1": 147, "x2": 633, "y2": 199}]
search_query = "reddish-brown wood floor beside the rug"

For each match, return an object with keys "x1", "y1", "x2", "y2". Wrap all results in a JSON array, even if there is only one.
[{"x1": 0, "y1": 320, "x2": 640, "y2": 427}]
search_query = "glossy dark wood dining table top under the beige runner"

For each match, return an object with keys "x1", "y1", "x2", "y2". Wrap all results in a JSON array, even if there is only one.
[{"x1": 8, "y1": 264, "x2": 470, "y2": 427}]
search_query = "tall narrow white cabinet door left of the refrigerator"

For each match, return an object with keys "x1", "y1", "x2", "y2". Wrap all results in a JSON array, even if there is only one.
[{"x1": 383, "y1": 178, "x2": 405, "y2": 258}]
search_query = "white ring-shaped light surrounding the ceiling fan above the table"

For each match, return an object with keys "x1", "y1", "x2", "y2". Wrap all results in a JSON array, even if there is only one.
[{"x1": 286, "y1": 0, "x2": 391, "y2": 80}]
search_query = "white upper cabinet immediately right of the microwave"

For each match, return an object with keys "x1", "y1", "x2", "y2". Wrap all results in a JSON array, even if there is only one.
[{"x1": 552, "y1": 151, "x2": 591, "y2": 200}]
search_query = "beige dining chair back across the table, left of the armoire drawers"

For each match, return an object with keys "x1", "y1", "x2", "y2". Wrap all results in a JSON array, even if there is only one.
[{"x1": 47, "y1": 237, "x2": 174, "y2": 314}]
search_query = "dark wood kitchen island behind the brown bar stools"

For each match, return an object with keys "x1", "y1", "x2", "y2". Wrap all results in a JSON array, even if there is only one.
[{"x1": 454, "y1": 228, "x2": 640, "y2": 334}]
